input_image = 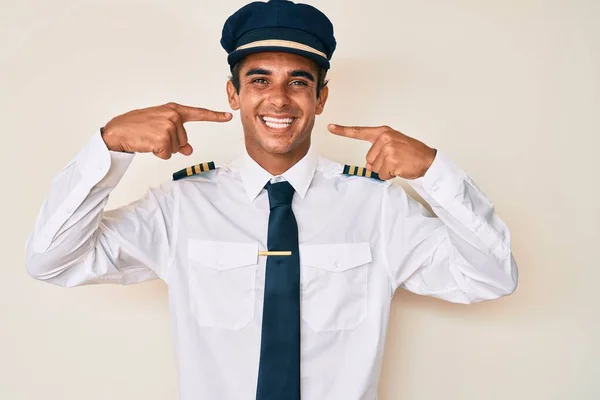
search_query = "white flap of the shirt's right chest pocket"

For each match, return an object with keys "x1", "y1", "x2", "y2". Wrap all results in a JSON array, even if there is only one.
[{"x1": 300, "y1": 243, "x2": 371, "y2": 272}]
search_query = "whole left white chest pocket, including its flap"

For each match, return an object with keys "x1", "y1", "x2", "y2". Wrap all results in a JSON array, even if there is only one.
[{"x1": 188, "y1": 239, "x2": 258, "y2": 330}]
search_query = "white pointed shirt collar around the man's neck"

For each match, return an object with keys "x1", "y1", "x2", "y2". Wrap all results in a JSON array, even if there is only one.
[{"x1": 233, "y1": 149, "x2": 318, "y2": 202}]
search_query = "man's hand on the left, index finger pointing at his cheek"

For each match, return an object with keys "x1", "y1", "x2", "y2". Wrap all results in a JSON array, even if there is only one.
[{"x1": 102, "y1": 103, "x2": 232, "y2": 160}]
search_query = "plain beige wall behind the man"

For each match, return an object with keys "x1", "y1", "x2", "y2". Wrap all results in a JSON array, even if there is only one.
[{"x1": 0, "y1": 0, "x2": 600, "y2": 400}]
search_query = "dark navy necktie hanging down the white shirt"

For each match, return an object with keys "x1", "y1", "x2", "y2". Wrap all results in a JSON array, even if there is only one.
[{"x1": 256, "y1": 182, "x2": 300, "y2": 400}]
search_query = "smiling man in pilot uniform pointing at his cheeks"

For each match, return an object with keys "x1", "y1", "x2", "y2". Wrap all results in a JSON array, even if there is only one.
[{"x1": 27, "y1": 1, "x2": 517, "y2": 400}]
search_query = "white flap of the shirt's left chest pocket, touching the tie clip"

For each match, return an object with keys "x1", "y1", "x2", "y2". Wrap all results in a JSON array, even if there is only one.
[{"x1": 188, "y1": 239, "x2": 258, "y2": 270}]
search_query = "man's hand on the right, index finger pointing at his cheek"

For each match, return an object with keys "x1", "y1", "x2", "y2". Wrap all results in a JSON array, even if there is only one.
[{"x1": 327, "y1": 124, "x2": 437, "y2": 180}]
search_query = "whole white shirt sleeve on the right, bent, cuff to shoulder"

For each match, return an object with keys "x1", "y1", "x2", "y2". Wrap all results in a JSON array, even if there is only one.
[{"x1": 382, "y1": 151, "x2": 518, "y2": 303}]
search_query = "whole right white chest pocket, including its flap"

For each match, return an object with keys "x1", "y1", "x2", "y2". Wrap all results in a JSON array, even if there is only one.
[{"x1": 300, "y1": 243, "x2": 371, "y2": 331}]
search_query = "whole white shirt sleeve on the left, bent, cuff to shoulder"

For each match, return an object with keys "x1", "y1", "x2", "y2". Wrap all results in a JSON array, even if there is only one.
[{"x1": 25, "y1": 132, "x2": 174, "y2": 287}]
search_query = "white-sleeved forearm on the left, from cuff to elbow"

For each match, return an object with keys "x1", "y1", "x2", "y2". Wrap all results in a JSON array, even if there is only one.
[{"x1": 26, "y1": 133, "x2": 133, "y2": 285}]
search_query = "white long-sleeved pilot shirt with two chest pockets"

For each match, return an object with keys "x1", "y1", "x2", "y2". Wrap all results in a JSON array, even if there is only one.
[{"x1": 26, "y1": 133, "x2": 517, "y2": 400}]
